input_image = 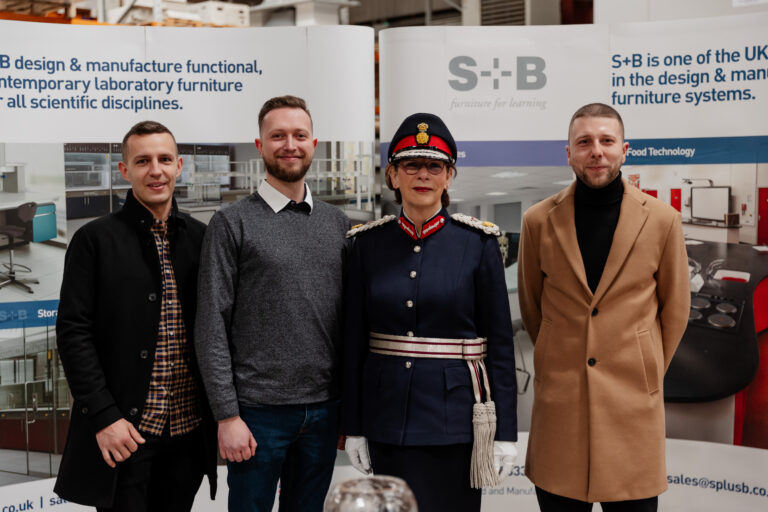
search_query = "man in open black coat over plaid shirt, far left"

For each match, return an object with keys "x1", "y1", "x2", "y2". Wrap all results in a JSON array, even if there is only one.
[{"x1": 54, "y1": 121, "x2": 216, "y2": 512}]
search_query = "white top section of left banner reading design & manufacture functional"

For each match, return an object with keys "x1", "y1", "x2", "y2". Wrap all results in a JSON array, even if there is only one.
[{"x1": 0, "y1": 21, "x2": 374, "y2": 143}]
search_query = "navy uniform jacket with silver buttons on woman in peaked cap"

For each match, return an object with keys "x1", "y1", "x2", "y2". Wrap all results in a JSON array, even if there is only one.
[{"x1": 342, "y1": 209, "x2": 517, "y2": 445}]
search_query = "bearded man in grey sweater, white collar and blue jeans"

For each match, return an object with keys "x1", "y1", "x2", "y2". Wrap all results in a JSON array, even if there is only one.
[{"x1": 195, "y1": 96, "x2": 349, "y2": 512}]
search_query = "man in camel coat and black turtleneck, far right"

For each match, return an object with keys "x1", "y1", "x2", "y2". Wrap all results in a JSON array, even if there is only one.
[{"x1": 518, "y1": 103, "x2": 690, "y2": 512}]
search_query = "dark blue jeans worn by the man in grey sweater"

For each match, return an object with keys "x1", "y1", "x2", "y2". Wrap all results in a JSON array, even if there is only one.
[{"x1": 227, "y1": 400, "x2": 339, "y2": 512}]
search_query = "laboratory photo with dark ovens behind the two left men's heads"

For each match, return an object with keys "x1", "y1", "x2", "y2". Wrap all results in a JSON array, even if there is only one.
[{"x1": 64, "y1": 141, "x2": 374, "y2": 230}]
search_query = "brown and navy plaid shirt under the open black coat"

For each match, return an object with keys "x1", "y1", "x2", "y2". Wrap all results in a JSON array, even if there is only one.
[{"x1": 139, "y1": 220, "x2": 202, "y2": 436}]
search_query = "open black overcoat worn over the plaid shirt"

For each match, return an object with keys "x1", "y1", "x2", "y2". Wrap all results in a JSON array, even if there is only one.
[{"x1": 54, "y1": 192, "x2": 216, "y2": 507}]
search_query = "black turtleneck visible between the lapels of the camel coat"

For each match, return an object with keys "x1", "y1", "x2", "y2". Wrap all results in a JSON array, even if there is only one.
[{"x1": 574, "y1": 172, "x2": 624, "y2": 293}]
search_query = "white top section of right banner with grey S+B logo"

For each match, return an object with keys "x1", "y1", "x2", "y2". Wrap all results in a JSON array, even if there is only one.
[{"x1": 380, "y1": 13, "x2": 768, "y2": 166}]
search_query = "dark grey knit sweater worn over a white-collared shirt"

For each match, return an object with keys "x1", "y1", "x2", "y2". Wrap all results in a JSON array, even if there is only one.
[{"x1": 195, "y1": 193, "x2": 349, "y2": 420}]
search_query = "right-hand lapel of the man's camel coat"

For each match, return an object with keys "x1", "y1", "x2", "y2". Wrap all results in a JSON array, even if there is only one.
[{"x1": 592, "y1": 182, "x2": 648, "y2": 305}]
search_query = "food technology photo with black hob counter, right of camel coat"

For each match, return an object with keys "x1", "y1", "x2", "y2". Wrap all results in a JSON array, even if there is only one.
[{"x1": 625, "y1": 161, "x2": 768, "y2": 449}]
